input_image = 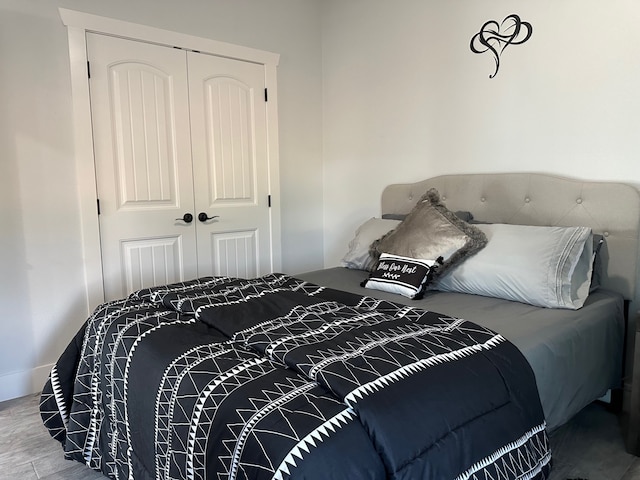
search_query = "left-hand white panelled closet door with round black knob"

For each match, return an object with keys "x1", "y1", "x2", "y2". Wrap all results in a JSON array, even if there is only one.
[{"x1": 87, "y1": 34, "x2": 197, "y2": 300}]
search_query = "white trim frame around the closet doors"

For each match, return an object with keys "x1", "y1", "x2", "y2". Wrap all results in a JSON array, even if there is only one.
[{"x1": 58, "y1": 8, "x2": 282, "y2": 314}]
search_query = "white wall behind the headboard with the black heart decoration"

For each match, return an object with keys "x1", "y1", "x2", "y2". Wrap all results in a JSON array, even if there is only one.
[{"x1": 323, "y1": 0, "x2": 640, "y2": 266}]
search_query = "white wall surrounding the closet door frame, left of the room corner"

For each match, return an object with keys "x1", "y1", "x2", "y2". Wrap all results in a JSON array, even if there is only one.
[{"x1": 0, "y1": 0, "x2": 323, "y2": 401}]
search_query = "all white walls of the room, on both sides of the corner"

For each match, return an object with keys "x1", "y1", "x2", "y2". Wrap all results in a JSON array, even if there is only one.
[{"x1": 5, "y1": 0, "x2": 640, "y2": 400}]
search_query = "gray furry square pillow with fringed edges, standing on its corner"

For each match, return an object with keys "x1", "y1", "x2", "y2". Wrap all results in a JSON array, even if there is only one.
[{"x1": 371, "y1": 188, "x2": 487, "y2": 278}]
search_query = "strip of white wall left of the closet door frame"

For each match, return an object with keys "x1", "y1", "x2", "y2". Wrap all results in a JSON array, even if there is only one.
[{"x1": 0, "y1": 7, "x2": 86, "y2": 399}]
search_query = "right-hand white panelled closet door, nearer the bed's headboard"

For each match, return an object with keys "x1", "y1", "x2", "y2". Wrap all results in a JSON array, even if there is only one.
[{"x1": 187, "y1": 52, "x2": 272, "y2": 278}]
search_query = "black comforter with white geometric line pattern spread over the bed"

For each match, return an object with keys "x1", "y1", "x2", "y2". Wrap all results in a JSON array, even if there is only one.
[{"x1": 41, "y1": 274, "x2": 551, "y2": 480}]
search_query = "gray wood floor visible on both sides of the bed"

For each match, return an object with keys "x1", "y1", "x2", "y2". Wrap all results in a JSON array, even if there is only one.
[{"x1": 0, "y1": 395, "x2": 640, "y2": 480}]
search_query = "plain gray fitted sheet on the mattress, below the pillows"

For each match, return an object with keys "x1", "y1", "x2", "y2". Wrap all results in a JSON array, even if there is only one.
[{"x1": 296, "y1": 267, "x2": 624, "y2": 430}]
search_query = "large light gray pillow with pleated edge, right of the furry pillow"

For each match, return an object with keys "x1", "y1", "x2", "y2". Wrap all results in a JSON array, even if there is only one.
[{"x1": 433, "y1": 224, "x2": 593, "y2": 310}]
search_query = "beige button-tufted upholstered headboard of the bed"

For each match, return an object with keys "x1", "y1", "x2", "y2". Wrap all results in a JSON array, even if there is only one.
[{"x1": 382, "y1": 173, "x2": 640, "y2": 308}]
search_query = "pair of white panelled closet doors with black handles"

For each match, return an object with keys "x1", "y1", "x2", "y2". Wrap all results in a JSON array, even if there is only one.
[{"x1": 87, "y1": 34, "x2": 274, "y2": 300}]
